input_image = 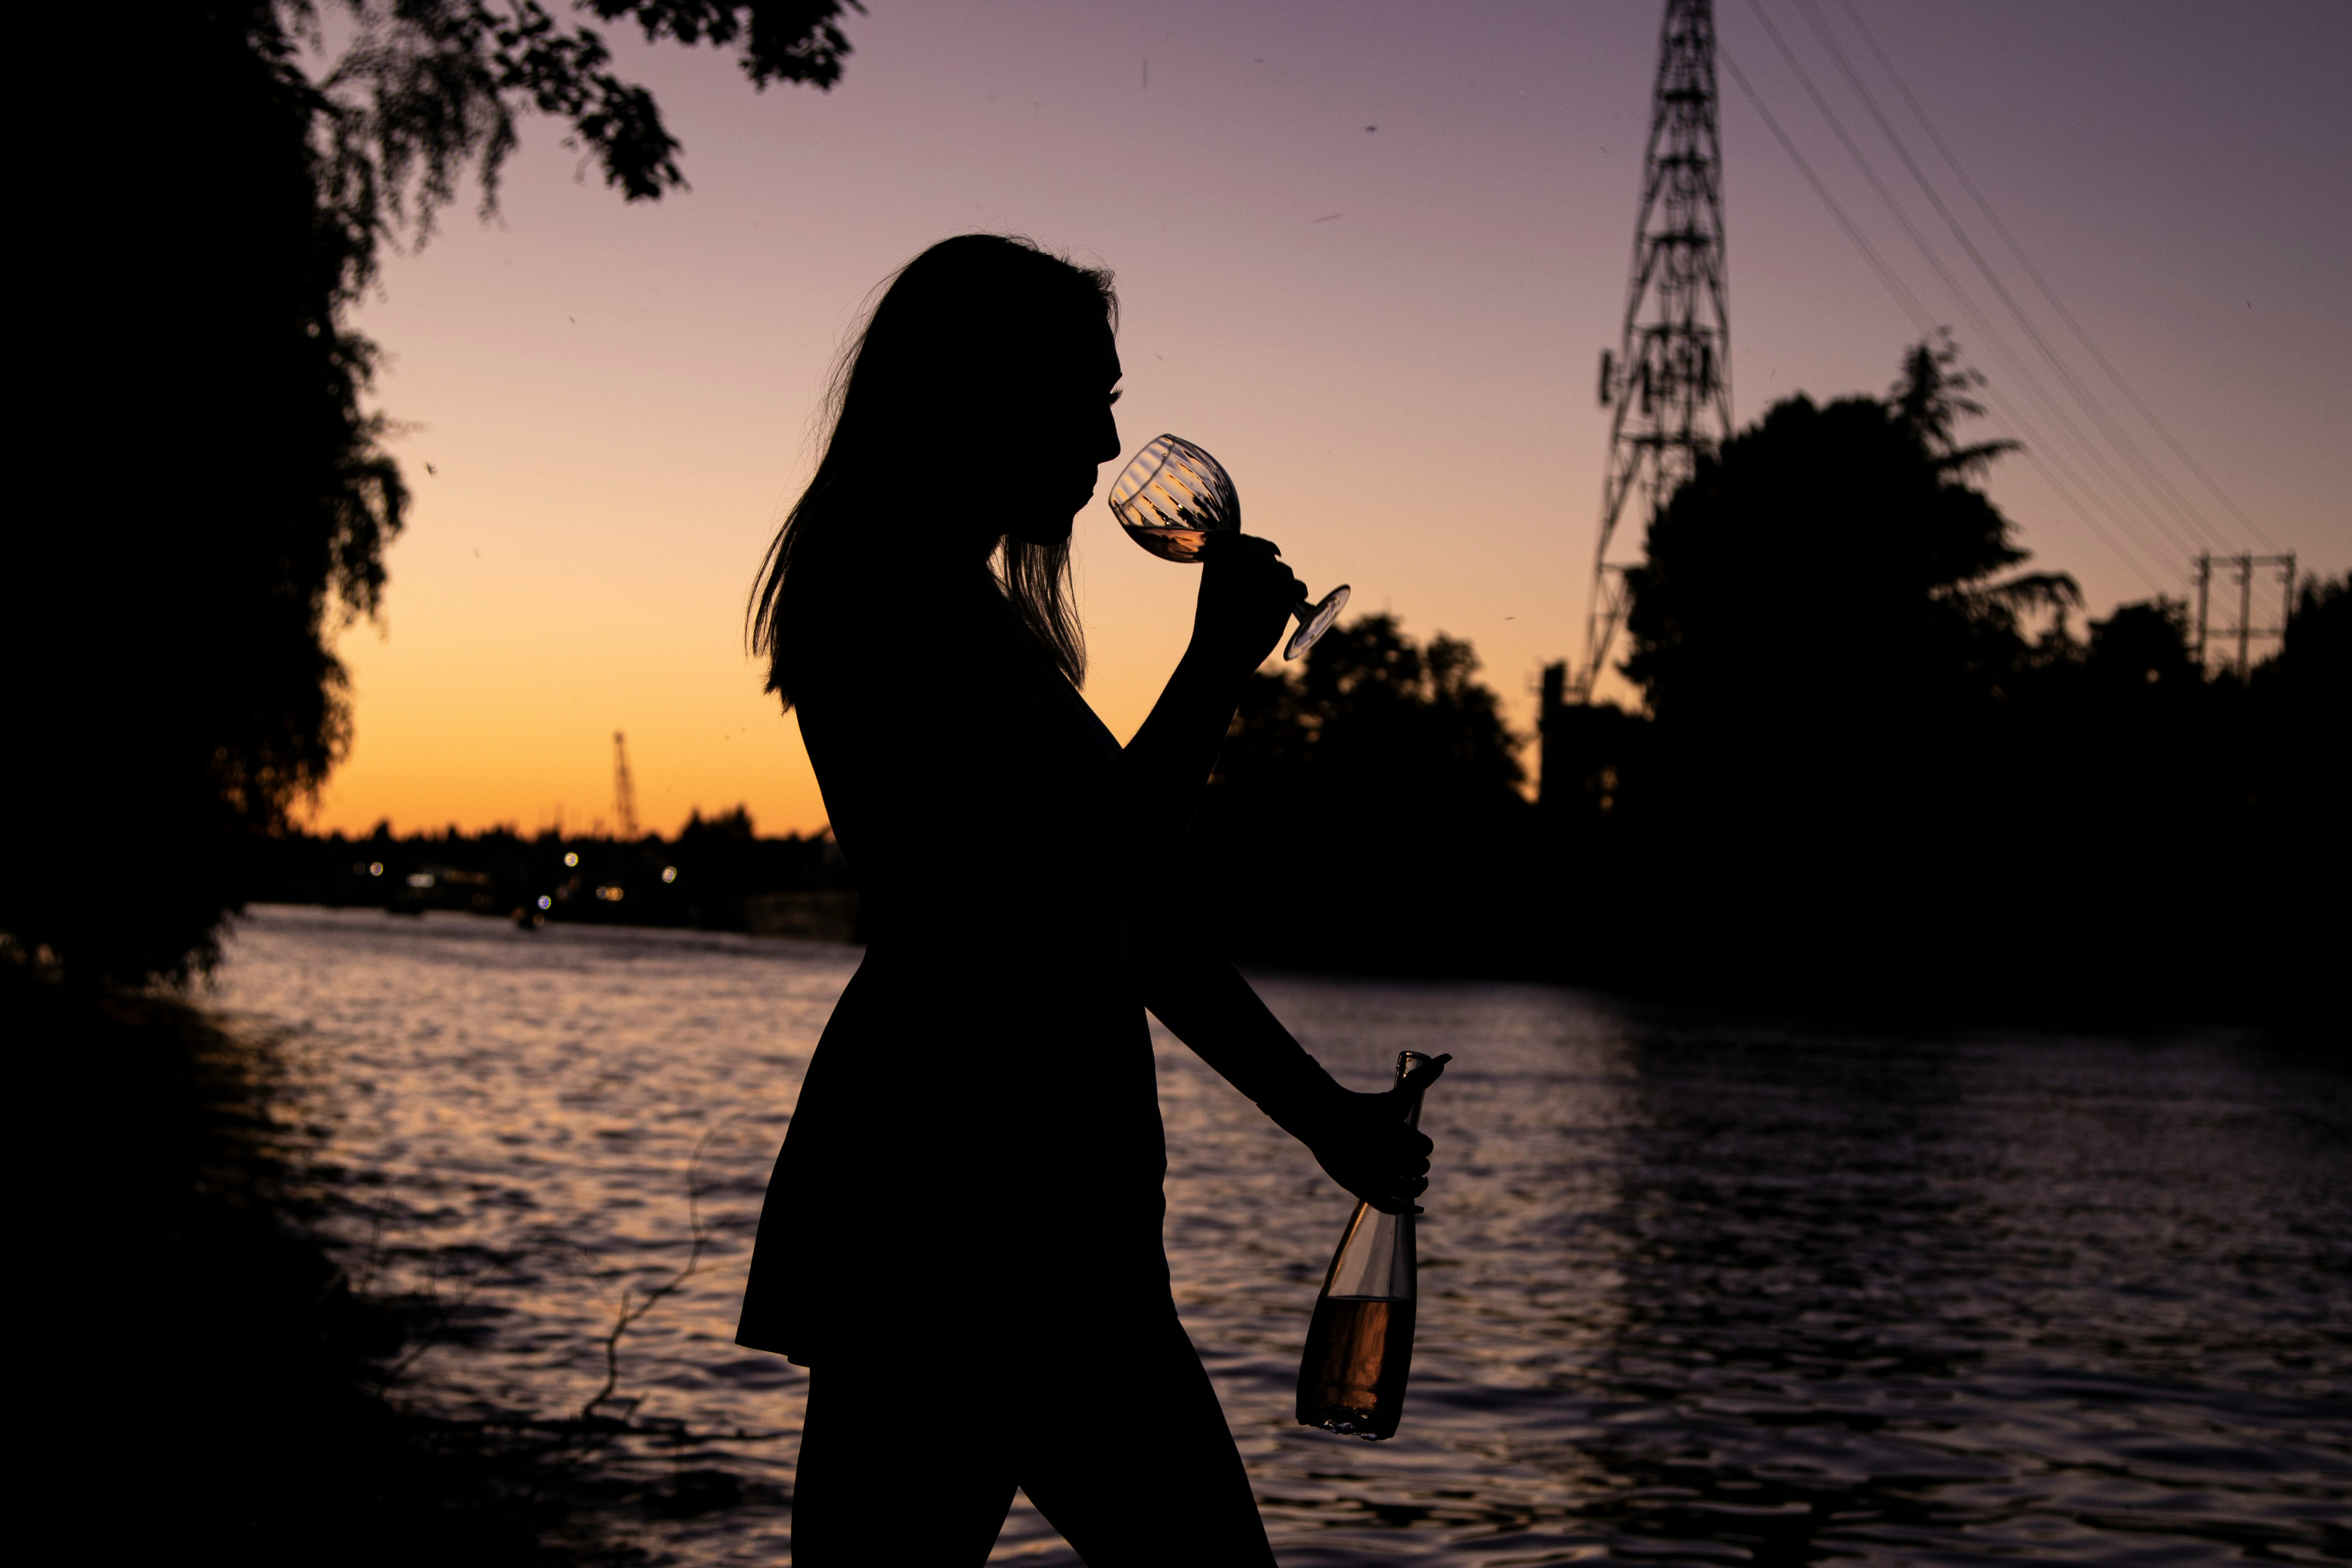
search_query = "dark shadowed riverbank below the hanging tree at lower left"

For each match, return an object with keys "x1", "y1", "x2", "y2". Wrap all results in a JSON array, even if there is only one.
[{"x1": 16, "y1": 966, "x2": 619, "y2": 1568}]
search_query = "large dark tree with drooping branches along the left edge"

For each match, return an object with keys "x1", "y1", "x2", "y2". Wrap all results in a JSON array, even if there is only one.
[{"x1": 0, "y1": 0, "x2": 865, "y2": 980}]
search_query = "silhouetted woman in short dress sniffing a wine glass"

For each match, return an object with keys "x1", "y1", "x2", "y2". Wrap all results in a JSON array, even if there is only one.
[{"x1": 736, "y1": 235, "x2": 1430, "y2": 1568}]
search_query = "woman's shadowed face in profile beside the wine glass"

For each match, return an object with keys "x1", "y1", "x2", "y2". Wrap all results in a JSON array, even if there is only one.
[{"x1": 1002, "y1": 317, "x2": 1120, "y2": 545}]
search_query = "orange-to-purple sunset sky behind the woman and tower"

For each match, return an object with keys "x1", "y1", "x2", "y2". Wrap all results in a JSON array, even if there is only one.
[{"x1": 315, "y1": 0, "x2": 2352, "y2": 832}]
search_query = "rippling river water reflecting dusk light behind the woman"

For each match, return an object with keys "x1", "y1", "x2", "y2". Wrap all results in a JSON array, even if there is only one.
[{"x1": 216, "y1": 907, "x2": 2352, "y2": 1568}]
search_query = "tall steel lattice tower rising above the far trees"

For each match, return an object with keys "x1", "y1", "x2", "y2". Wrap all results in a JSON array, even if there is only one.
[{"x1": 1571, "y1": 0, "x2": 1731, "y2": 703}]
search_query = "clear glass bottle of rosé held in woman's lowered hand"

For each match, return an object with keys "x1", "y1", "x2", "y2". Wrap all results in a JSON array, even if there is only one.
[{"x1": 1298, "y1": 1051, "x2": 1444, "y2": 1441}]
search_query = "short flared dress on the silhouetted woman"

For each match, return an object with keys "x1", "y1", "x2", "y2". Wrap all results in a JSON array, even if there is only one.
[{"x1": 736, "y1": 574, "x2": 1176, "y2": 1373}]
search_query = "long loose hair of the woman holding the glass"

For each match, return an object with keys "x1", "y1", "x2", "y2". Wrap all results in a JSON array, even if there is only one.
[{"x1": 748, "y1": 235, "x2": 1120, "y2": 707}]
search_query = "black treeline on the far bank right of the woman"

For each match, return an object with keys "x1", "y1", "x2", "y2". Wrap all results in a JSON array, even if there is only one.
[{"x1": 1183, "y1": 343, "x2": 2352, "y2": 1020}]
